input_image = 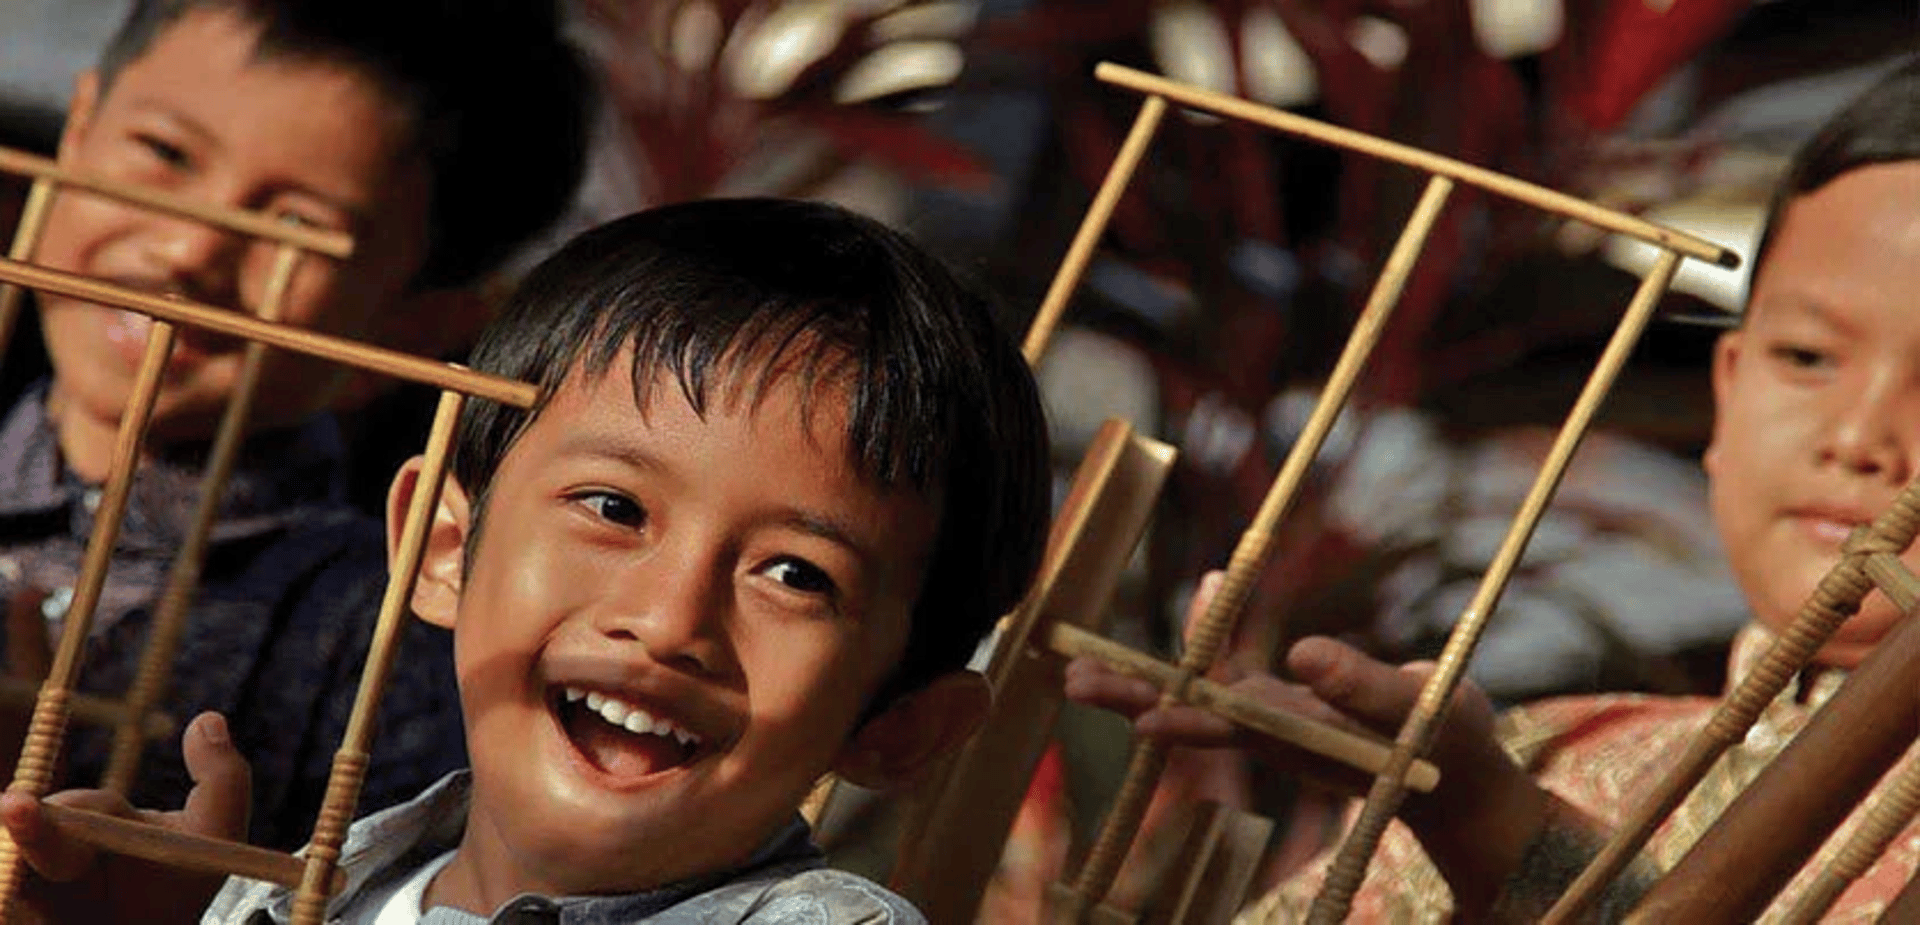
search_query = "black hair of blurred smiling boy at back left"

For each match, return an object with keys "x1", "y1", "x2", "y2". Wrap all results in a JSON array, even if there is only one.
[{"x1": 100, "y1": 0, "x2": 593, "y2": 290}]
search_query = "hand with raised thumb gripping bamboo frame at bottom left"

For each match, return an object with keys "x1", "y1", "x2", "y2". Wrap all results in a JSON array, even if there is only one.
[{"x1": 0, "y1": 712, "x2": 252, "y2": 923}]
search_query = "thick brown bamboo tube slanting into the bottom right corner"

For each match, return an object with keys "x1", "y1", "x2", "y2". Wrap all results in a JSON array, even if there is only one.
[{"x1": 1632, "y1": 587, "x2": 1920, "y2": 923}]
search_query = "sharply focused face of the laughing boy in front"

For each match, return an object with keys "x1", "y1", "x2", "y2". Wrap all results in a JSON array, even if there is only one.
[{"x1": 415, "y1": 357, "x2": 937, "y2": 898}]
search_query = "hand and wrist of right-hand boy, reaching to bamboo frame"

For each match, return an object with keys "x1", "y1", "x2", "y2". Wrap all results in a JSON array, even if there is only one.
[{"x1": 1068, "y1": 589, "x2": 1553, "y2": 921}]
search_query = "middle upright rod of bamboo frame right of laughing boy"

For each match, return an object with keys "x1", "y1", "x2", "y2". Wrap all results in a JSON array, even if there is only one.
[{"x1": 1064, "y1": 177, "x2": 1453, "y2": 919}]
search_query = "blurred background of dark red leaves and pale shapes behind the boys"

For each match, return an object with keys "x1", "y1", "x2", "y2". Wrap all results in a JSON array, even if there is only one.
[{"x1": 0, "y1": 0, "x2": 1920, "y2": 913}]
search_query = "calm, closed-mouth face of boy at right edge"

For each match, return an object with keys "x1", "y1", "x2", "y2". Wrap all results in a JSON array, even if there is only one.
[{"x1": 1705, "y1": 161, "x2": 1920, "y2": 666}]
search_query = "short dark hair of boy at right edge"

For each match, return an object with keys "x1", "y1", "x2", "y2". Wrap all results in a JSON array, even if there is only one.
[{"x1": 1753, "y1": 58, "x2": 1920, "y2": 284}]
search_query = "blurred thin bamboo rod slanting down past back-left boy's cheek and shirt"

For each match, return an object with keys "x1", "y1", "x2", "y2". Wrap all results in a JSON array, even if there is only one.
[{"x1": 102, "y1": 244, "x2": 300, "y2": 796}]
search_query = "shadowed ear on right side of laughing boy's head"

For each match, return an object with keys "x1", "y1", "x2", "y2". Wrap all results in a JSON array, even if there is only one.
[{"x1": 833, "y1": 672, "x2": 993, "y2": 789}]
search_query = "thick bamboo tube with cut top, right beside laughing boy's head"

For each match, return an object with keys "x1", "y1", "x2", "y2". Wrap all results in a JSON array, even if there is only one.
[{"x1": 891, "y1": 420, "x2": 1173, "y2": 923}]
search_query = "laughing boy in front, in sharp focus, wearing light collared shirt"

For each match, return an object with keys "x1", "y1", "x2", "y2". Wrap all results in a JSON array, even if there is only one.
[{"x1": 0, "y1": 200, "x2": 1048, "y2": 925}]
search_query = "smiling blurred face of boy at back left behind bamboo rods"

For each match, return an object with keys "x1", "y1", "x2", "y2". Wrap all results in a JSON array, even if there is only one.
[{"x1": 36, "y1": 12, "x2": 428, "y2": 474}]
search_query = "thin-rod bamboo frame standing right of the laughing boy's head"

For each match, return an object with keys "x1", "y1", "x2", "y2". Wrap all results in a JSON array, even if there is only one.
[{"x1": 967, "y1": 63, "x2": 1740, "y2": 921}]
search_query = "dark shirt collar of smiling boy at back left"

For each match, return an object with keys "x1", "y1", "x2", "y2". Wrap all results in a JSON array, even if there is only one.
[{"x1": 0, "y1": 380, "x2": 346, "y2": 551}]
